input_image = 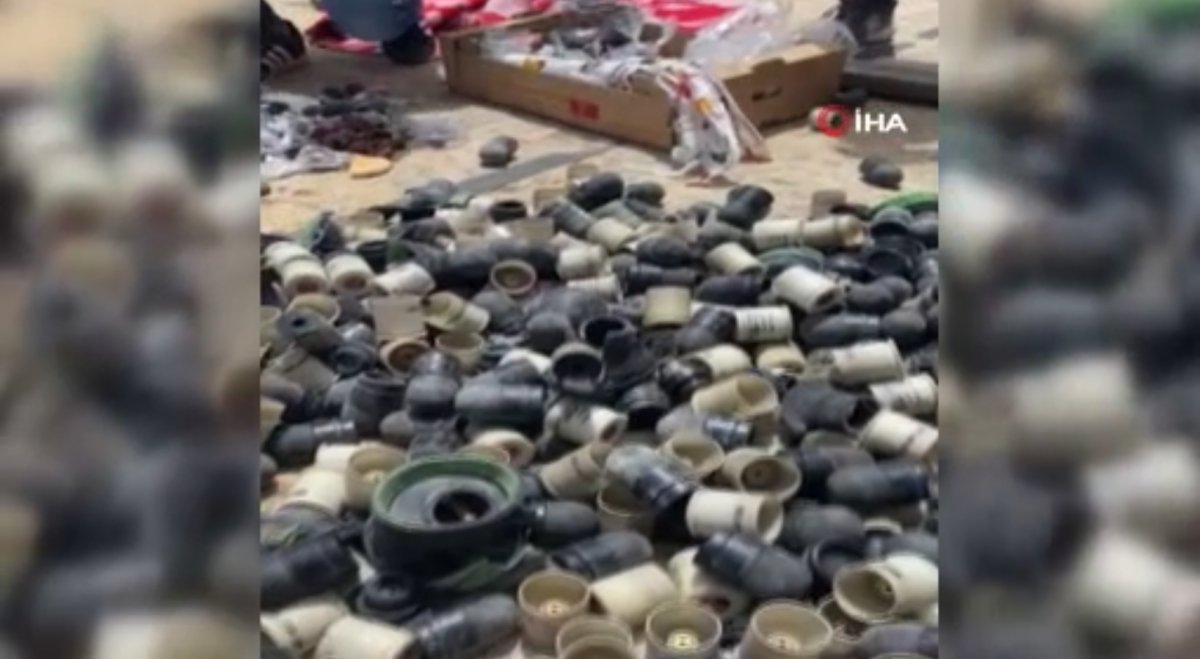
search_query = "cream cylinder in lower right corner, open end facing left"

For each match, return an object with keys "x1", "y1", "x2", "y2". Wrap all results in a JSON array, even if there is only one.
[{"x1": 833, "y1": 553, "x2": 937, "y2": 623}]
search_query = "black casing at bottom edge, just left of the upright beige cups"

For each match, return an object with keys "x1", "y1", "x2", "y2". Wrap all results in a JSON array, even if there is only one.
[{"x1": 409, "y1": 595, "x2": 521, "y2": 659}]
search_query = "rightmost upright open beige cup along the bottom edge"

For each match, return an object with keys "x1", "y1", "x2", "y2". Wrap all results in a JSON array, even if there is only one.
[{"x1": 739, "y1": 601, "x2": 833, "y2": 659}]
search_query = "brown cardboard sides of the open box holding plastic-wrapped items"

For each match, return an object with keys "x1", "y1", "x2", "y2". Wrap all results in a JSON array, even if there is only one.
[{"x1": 440, "y1": 14, "x2": 845, "y2": 150}]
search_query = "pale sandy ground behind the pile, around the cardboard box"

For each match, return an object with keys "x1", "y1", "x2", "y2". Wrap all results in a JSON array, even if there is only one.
[{"x1": 262, "y1": 0, "x2": 937, "y2": 232}]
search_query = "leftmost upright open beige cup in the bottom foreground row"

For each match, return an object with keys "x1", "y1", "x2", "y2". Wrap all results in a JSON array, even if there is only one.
[{"x1": 517, "y1": 570, "x2": 592, "y2": 652}]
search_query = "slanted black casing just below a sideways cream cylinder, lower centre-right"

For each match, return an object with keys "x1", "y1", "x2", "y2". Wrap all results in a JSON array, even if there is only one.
[{"x1": 696, "y1": 533, "x2": 812, "y2": 600}]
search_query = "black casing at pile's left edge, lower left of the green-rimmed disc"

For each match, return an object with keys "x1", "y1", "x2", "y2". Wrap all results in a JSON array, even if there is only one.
[{"x1": 259, "y1": 534, "x2": 359, "y2": 611}]
